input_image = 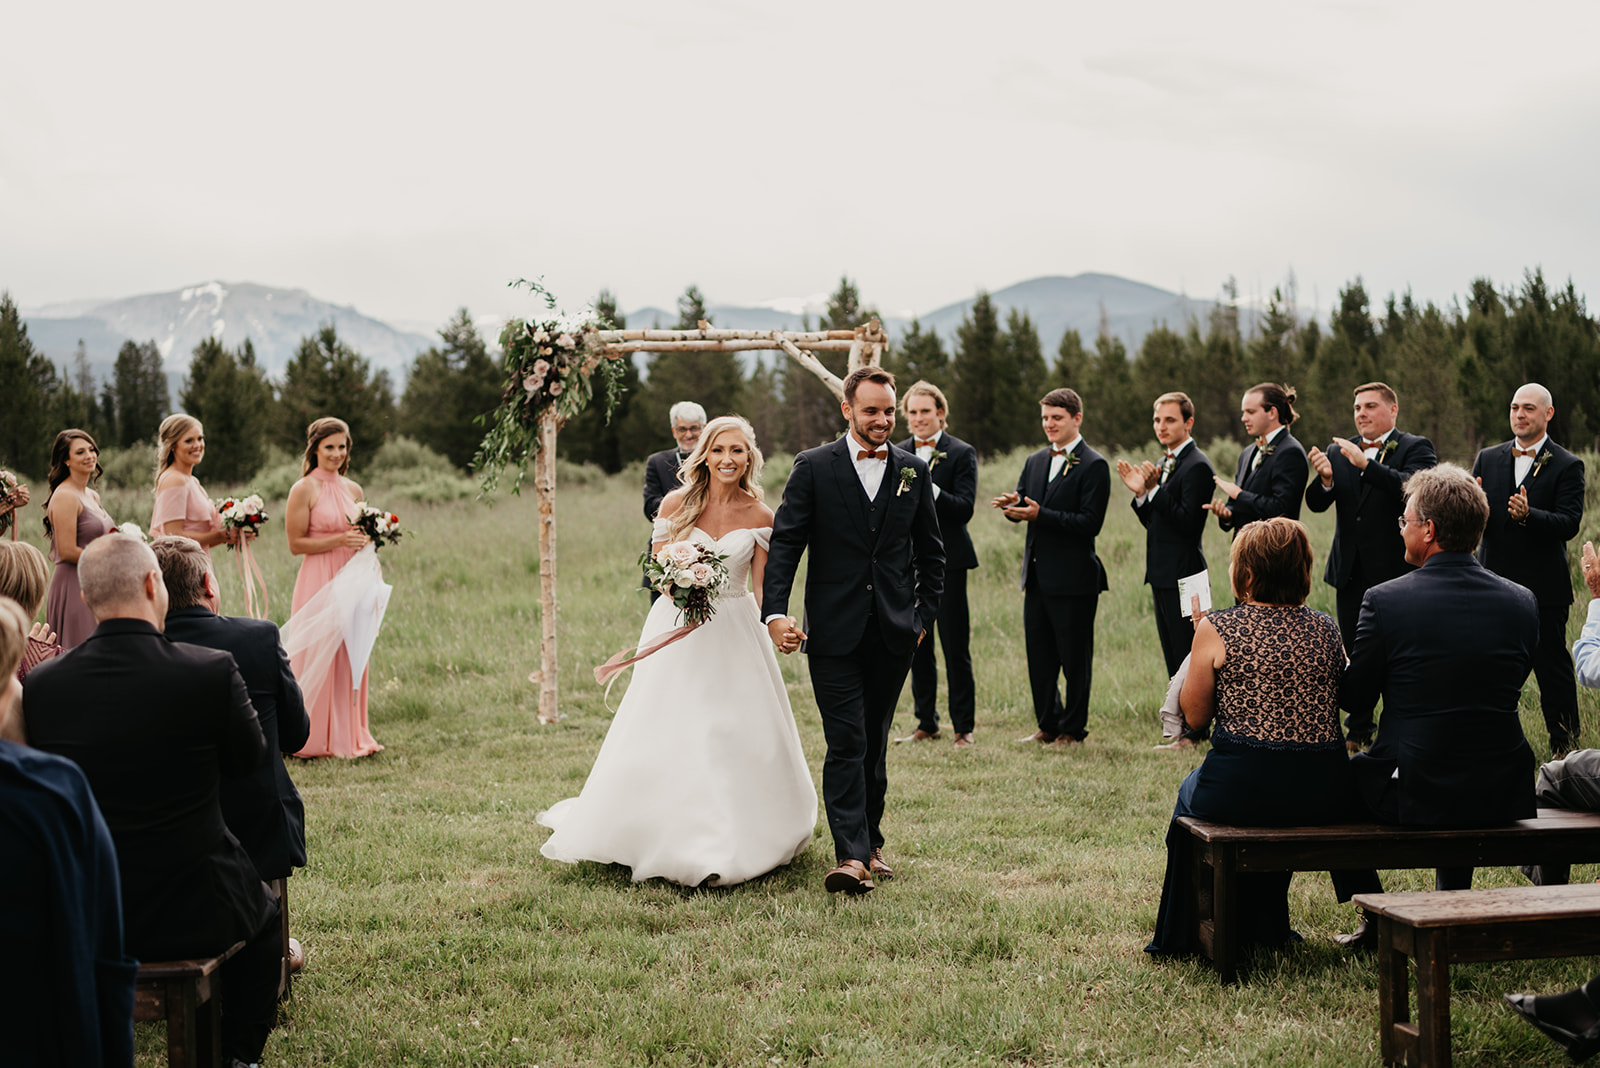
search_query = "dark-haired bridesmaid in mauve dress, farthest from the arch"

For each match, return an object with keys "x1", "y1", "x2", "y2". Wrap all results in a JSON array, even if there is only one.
[{"x1": 45, "y1": 430, "x2": 117, "y2": 649}]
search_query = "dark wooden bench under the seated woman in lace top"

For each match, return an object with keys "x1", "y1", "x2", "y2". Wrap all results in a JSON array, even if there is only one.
[{"x1": 1178, "y1": 809, "x2": 1600, "y2": 983}]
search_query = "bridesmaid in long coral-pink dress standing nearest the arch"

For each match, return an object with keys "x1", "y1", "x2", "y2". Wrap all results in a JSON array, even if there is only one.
[{"x1": 283, "y1": 419, "x2": 382, "y2": 758}]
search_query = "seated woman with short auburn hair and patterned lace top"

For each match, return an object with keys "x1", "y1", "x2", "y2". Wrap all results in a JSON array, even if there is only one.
[{"x1": 1144, "y1": 516, "x2": 1355, "y2": 954}]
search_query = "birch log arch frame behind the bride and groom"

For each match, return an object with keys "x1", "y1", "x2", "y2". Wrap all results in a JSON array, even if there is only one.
[{"x1": 521, "y1": 318, "x2": 888, "y2": 723}]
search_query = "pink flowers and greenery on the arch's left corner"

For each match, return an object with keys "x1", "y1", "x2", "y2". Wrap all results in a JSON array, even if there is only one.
[{"x1": 472, "y1": 280, "x2": 622, "y2": 492}]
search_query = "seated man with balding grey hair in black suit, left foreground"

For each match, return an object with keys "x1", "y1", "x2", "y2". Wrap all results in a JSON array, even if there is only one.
[{"x1": 22, "y1": 534, "x2": 282, "y2": 1063}]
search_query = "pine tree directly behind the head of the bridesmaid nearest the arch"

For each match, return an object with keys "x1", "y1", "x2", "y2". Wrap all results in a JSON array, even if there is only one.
[{"x1": 278, "y1": 323, "x2": 395, "y2": 467}]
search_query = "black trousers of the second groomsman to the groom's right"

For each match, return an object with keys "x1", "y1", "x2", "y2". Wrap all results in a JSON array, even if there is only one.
[{"x1": 1022, "y1": 576, "x2": 1099, "y2": 740}]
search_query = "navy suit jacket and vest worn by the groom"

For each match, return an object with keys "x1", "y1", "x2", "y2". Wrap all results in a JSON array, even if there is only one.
[{"x1": 762, "y1": 435, "x2": 944, "y2": 656}]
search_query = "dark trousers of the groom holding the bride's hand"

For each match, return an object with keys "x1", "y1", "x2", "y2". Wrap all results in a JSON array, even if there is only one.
[{"x1": 808, "y1": 617, "x2": 910, "y2": 863}]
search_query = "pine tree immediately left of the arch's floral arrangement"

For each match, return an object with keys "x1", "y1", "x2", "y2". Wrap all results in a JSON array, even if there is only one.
[{"x1": 395, "y1": 309, "x2": 504, "y2": 470}]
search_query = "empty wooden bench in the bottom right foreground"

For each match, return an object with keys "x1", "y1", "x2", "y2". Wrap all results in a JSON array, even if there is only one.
[{"x1": 1355, "y1": 883, "x2": 1600, "y2": 1068}]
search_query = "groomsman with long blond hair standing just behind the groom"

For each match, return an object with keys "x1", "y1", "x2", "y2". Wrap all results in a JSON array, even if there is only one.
[{"x1": 899, "y1": 382, "x2": 978, "y2": 748}]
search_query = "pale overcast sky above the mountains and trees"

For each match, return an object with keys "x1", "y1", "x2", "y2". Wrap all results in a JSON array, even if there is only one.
[{"x1": 0, "y1": 0, "x2": 1600, "y2": 323}]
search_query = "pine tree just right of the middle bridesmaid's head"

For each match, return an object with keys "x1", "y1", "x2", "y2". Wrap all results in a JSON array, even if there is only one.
[{"x1": 178, "y1": 337, "x2": 274, "y2": 483}]
